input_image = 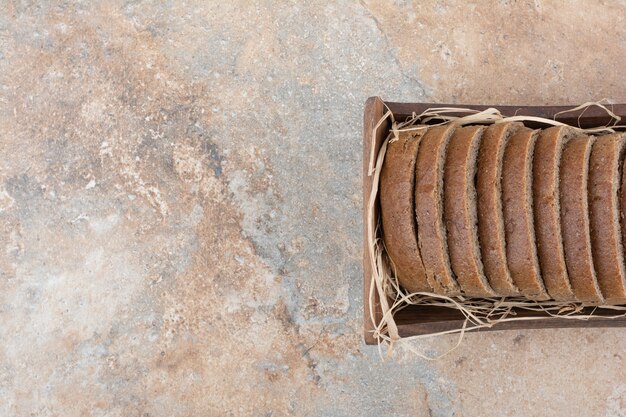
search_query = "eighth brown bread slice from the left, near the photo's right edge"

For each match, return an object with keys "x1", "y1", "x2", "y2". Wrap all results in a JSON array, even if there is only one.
[{"x1": 587, "y1": 133, "x2": 626, "y2": 304}]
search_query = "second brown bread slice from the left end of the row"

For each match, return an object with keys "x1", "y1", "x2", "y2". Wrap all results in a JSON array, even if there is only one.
[{"x1": 415, "y1": 124, "x2": 461, "y2": 295}]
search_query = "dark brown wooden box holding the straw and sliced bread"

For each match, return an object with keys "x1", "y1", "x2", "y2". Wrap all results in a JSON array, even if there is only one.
[{"x1": 363, "y1": 97, "x2": 626, "y2": 345}]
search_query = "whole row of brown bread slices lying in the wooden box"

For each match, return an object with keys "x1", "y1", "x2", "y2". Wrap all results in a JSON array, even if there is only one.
[{"x1": 380, "y1": 122, "x2": 626, "y2": 304}]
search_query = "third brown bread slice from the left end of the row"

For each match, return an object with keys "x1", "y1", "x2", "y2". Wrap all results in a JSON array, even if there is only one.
[{"x1": 444, "y1": 126, "x2": 496, "y2": 297}]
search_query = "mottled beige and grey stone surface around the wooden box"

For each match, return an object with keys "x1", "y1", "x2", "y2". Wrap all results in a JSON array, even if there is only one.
[{"x1": 0, "y1": 0, "x2": 626, "y2": 417}]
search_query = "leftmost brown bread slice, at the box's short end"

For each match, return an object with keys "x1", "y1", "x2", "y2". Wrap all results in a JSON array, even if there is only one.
[{"x1": 380, "y1": 130, "x2": 432, "y2": 292}]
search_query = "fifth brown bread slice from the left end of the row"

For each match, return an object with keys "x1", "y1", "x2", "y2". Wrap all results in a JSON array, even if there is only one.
[{"x1": 502, "y1": 127, "x2": 549, "y2": 300}]
